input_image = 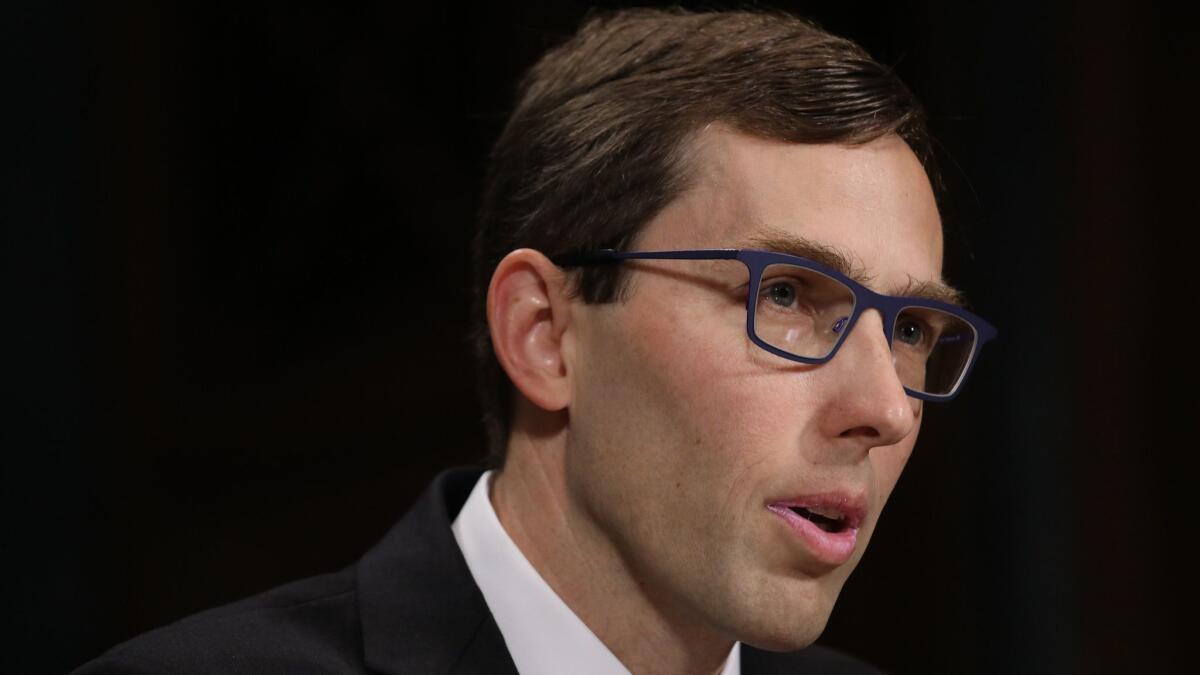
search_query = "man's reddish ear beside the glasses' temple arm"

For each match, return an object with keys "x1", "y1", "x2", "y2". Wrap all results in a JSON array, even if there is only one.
[{"x1": 487, "y1": 249, "x2": 571, "y2": 411}]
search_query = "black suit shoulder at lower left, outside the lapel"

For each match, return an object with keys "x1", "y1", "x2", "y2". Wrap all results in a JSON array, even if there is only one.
[{"x1": 76, "y1": 568, "x2": 364, "y2": 675}]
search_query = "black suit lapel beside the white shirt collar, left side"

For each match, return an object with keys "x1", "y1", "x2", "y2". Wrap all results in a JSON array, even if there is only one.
[{"x1": 358, "y1": 468, "x2": 516, "y2": 675}]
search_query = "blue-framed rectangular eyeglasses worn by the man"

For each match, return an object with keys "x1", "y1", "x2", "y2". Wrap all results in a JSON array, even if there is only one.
[{"x1": 558, "y1": 249, "x2": 996, "y2": 401}]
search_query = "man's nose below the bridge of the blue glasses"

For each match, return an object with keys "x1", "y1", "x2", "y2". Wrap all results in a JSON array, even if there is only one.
[{"x1": 822, "y1": 310, "x2": 920, "y2": 449}]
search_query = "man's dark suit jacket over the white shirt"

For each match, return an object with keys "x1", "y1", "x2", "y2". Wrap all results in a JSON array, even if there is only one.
[{"x1": 76, "y1": 468, "x2": 877, "y2": 675}]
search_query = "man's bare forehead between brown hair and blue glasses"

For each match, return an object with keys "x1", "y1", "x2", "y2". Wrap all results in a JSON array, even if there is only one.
[{"x1": 637, "y1": 125, "x2": 942, "y2": 292}]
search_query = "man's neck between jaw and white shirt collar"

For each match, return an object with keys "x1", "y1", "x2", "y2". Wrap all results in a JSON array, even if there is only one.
[{"x1": 490, "y1": 417, "x2": 733, "y2": 674}]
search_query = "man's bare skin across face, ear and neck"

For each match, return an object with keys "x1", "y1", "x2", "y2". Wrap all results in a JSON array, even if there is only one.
[{"x1": 488, "y1": 125, "x2": 942, "y2": 673}]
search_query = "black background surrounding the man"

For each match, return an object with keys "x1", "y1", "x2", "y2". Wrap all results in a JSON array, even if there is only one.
[{"x1": 0, "y1": 1, "x2": 1200, "y2": 673}]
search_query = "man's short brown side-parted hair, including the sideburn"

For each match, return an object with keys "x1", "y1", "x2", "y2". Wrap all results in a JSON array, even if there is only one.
[{"x1": 473, "y1": 10, "x2": 936, "y2": 466}]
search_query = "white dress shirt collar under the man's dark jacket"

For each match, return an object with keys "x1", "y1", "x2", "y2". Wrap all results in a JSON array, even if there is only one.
[{"x1": 451, "y1": 471, "x2": 742, "y2": 675}]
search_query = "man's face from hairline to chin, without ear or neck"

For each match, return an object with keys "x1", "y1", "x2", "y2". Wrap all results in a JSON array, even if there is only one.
[{"x1": 565, "y1": 126, "x2": 942, "y2": 649}]
